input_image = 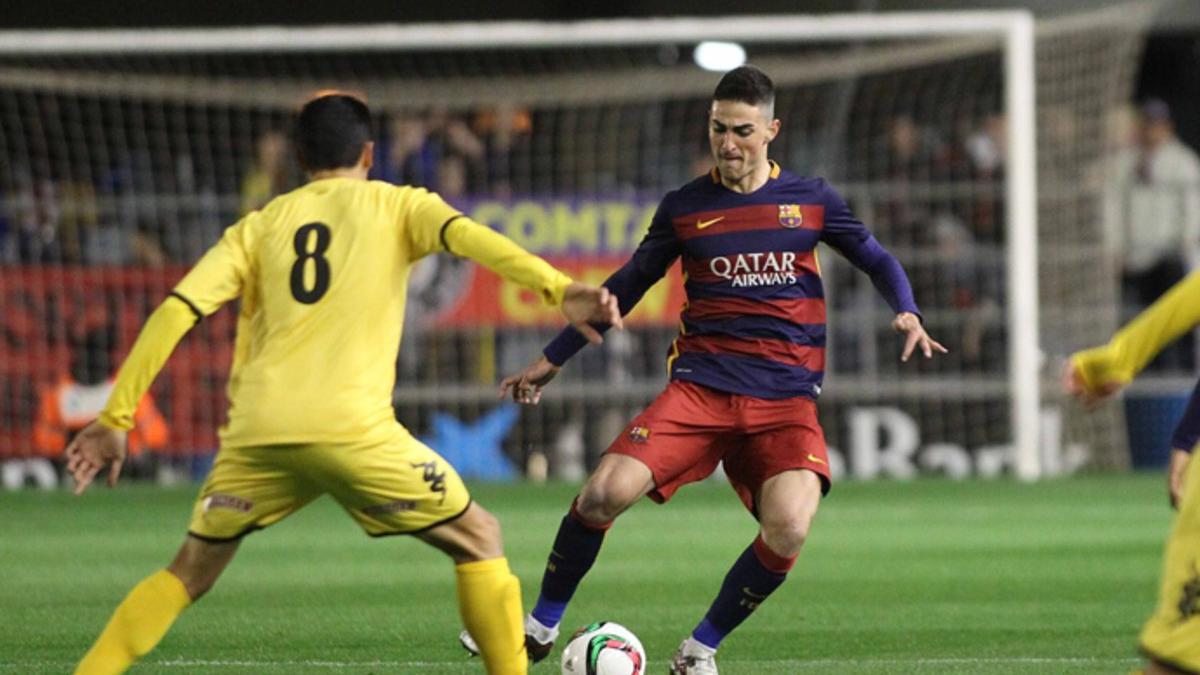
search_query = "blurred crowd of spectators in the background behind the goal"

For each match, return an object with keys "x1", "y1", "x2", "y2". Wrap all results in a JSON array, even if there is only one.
[{"x1": 0, "y1": 94, "x2": 1200, "y2": 475}]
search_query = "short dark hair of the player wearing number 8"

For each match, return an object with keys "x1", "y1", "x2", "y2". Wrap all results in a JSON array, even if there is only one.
[{"x1": 295, "y1": 94, "x2": 372, "y2": 172}]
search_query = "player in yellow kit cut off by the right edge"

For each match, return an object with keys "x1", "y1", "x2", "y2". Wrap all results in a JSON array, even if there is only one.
[{"x1": 1064, "y1": 273, "x2": 1200, "y2": 675}]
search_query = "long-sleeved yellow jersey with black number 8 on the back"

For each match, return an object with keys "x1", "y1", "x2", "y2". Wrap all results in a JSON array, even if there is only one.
[{"x1": 101, "y1": 178, "x2": 571, "y2": 446}]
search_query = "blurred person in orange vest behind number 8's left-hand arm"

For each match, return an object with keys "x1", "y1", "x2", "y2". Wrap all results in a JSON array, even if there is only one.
[{"x1": 34, "y1": 327, "x2": 168, "y2": 477}]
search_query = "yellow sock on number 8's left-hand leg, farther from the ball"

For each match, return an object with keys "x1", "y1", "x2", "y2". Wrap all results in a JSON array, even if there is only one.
[{"x1": 76, "y1": 567, "x2": 189, "y2": 675}]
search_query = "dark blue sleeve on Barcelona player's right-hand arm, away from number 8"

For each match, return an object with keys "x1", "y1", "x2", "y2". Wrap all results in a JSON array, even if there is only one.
[{"x1": 821, "y1": 177, "x2": 920, "y2": 317}]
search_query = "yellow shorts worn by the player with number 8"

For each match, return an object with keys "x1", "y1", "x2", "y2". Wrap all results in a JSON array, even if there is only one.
[{"x1": 188, "y1": 429, "x2": 470, "y2": 542}]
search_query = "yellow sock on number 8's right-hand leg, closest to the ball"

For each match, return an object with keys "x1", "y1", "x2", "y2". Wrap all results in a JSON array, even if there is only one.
[{"x1": 455, "y1": 557, "x2": 529, "y2": 675}]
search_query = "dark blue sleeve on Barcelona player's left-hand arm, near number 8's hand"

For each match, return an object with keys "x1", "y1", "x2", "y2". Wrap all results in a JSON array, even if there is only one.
[{"x1": 542, "y1": 195, "x2": 682, "y2": 365}]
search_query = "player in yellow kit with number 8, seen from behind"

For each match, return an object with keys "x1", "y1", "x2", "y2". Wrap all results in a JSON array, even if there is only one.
[{"x1": 67, "y1": 92, "x2": 620, "y2": 675}]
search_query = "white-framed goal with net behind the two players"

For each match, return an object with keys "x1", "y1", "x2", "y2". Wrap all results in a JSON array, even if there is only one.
[{"x1": 0, "y1": 2, "x2": 1150, "y2": 478}]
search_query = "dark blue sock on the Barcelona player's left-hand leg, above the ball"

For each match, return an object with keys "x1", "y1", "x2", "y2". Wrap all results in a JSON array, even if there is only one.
[{"x1": 530, "y1": 502, "x2": 612, "y2": 628}]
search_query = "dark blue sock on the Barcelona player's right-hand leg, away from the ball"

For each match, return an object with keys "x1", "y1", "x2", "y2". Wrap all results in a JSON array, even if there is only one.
[{"x1": 691, "y1": 534, "x2": 796, "y2": 650}]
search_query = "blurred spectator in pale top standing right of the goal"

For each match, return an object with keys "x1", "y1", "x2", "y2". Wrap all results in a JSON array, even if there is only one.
[{"x1": 1104, "y1": 98, "x2": 1200, "y2": 370}]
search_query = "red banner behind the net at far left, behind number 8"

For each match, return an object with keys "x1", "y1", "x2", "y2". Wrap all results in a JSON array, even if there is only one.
[{"x1": 0, "y1": 267, "x2": 231, "y2": 458}]
